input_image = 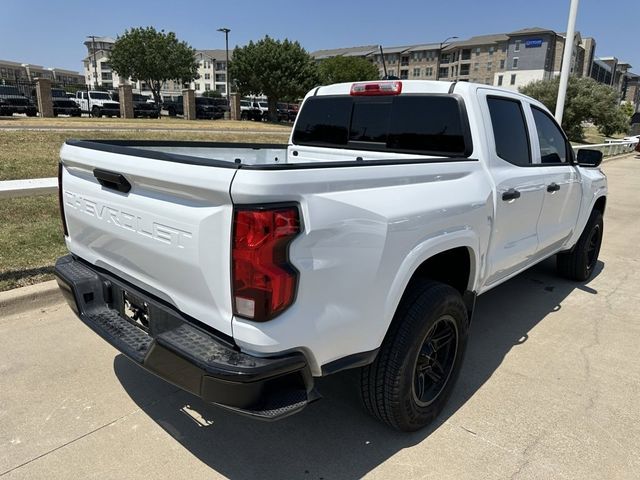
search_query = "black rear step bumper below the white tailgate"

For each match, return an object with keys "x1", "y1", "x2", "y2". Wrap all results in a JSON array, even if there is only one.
[{"x1": 55, "y1": 255, "x2": 315, "y2": 420}]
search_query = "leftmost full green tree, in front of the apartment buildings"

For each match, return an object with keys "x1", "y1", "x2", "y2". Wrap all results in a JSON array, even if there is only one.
[{"x1": 109, "y1": 27, "x2": 198, "y2": 103}]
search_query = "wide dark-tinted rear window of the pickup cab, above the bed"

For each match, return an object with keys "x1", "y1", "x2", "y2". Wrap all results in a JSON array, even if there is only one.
[{"x1": 293, "y1": 95, "x2": 472, "y2": 156}]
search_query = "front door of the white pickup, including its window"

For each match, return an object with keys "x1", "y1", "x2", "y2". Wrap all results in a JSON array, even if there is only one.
[{"x1": 531, "y1": 105, "x2": 582, "y2": 258}]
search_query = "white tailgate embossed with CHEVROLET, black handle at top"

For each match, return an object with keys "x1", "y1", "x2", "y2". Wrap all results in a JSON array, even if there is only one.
[{"x1": 61, "y1": 144, "x2": 236, "y2": 335}]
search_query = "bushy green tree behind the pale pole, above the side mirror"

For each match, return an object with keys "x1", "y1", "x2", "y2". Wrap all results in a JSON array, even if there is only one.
[{"x1": 520, "y1": 76, "x2": 628, "y2": 141}]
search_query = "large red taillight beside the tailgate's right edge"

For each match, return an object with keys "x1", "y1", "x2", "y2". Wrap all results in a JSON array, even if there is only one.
[{"x1": 231, "y1": 207, "x2": 300, "y2": 322}]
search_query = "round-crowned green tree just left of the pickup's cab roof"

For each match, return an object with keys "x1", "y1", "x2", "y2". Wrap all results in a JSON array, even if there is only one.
[{"x1": 229, "y1": 35, "x2": 318, "y2": 121}]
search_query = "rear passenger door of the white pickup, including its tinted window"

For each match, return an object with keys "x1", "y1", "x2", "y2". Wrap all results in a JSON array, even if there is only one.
[{"x1": 479, "y1": 91, "x2": 546, "y2": 287}]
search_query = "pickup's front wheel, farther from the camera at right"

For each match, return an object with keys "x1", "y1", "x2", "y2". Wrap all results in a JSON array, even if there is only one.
[{"x1": 556, "y1": 210, "x2": 604, "y2": 282}]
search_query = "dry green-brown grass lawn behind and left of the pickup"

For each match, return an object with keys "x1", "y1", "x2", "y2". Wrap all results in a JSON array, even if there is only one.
[{"x1": 0, "y1": 124, "x2": 290, "y2": 291}]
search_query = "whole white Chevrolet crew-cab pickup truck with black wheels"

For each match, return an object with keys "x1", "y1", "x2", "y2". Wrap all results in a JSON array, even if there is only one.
[{"x1": 55, "y1": 81, "x2": 607, "y2": 431}]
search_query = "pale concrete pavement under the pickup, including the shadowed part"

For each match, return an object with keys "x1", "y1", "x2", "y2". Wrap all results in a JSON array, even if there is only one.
[{"x1": 0, "y1": 155, "x2": 640, "y2": 480}]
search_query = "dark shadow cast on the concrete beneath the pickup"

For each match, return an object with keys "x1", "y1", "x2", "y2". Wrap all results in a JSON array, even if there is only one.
[{"x1": 114, "y1": 260, "x2": 603, "y2": 479}]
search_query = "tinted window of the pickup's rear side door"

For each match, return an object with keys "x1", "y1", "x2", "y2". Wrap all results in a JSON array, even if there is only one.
[{"x1": 487, "y1": 97, "x2": 531, "y2": 167}]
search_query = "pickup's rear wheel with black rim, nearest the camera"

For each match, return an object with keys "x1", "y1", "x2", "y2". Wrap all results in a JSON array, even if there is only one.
[{"x1": 360, "y1": 281, "x2": 469, "y2": 432}]
